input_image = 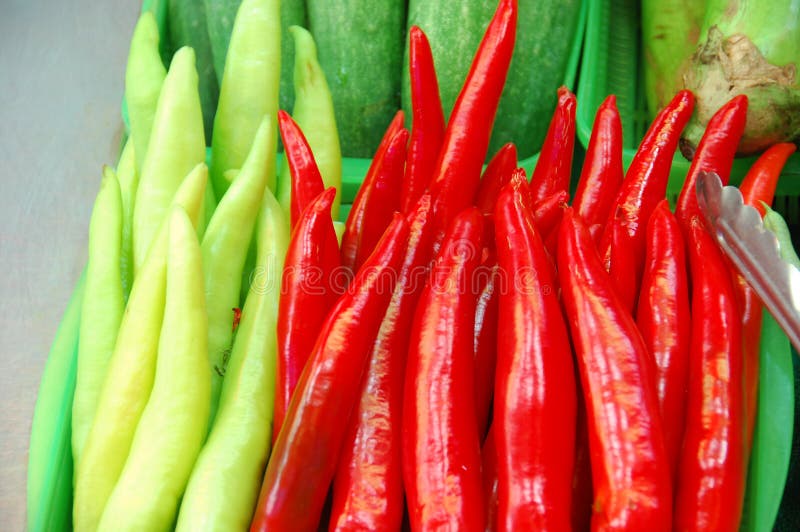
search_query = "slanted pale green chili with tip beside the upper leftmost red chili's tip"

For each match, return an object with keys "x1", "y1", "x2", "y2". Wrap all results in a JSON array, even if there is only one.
[{"x1": 201, "y1": 117, "x2": 277, "y2": 425}]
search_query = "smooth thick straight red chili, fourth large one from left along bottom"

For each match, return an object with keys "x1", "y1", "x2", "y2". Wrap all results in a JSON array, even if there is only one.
[{"x1": 493, "y1": 183, "x2": 577, "y2": 530}]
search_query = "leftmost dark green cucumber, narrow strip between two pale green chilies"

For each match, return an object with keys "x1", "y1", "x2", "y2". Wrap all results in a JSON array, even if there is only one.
[{"x1": 168, "y1": 0, "x2": 219, "y2": 141}]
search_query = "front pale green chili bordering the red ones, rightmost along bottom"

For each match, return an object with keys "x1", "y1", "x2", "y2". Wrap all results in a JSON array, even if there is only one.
[{"x1": 177, "y1": 188, "x2": 289, "y2": 532}]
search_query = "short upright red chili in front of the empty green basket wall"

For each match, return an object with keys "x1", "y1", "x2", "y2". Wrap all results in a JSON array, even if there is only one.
[{"x1": 572, "y1": 94, "x2": 624, "y2": 235}]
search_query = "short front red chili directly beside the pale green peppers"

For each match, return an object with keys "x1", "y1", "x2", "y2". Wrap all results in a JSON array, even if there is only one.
[{"x1": 272, "y1": 187, "x2": 339, "y2": 443}]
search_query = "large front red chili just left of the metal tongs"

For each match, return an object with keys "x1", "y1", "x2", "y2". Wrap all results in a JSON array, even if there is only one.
[{"x1": 675, "y1": 217, "x2": 745, "y2": 530}]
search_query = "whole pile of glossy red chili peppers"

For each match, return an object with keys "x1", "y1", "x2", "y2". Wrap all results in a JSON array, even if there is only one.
[{"x1": 252, "y1": 0, "x2": 793, "y2": 530}]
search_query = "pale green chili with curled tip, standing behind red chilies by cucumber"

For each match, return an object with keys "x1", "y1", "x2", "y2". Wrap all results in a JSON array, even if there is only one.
[{"x1": 278, "y1": 26, "x2": 342, "y2": 220}]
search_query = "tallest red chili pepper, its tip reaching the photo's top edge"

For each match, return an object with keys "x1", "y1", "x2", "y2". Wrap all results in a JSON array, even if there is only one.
[{"x1": 430, "y1": 0, "x2": 517, "y2": 247}]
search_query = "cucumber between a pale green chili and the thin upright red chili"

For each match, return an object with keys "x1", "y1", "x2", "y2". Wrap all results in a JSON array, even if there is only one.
[{"x1": 306, "y1": 0, "x2": 406, "y2": 157}]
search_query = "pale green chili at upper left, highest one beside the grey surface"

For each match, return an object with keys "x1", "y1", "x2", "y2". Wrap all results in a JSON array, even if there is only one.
[{"x1": 125, "y1": 11, "x2": 167, "y2": 171}]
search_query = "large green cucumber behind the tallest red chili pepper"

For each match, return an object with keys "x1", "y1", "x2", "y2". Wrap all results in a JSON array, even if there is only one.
[{"x1": 402, "y1": 0, "x2": 581, "y2": 159}]
